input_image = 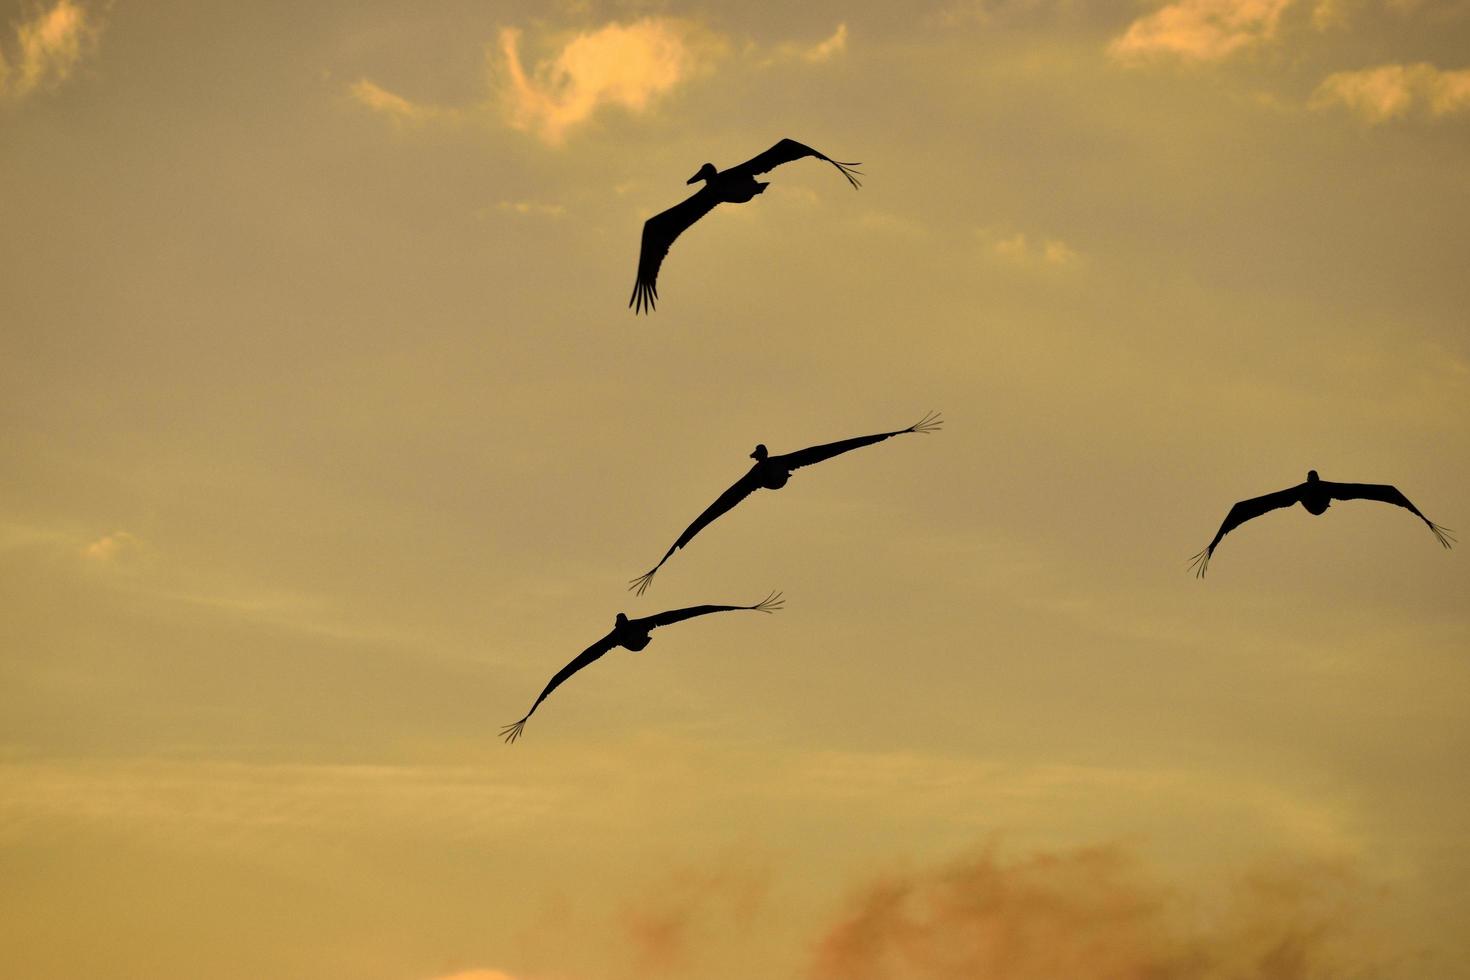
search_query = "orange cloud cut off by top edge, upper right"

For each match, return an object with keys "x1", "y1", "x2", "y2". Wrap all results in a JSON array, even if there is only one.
[{"x1": 1108, "y1": 0, "x2": 1292, "y2": 65}]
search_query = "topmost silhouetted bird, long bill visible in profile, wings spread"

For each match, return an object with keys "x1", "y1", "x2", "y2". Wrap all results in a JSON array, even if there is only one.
[{"x1": 628, "y1": 140, "x2": 861, "y2": 313}]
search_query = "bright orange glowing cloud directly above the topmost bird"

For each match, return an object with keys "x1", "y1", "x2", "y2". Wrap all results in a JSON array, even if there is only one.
[{"x1": 500, "y1": 18, "x2": 713, "y2": 145}]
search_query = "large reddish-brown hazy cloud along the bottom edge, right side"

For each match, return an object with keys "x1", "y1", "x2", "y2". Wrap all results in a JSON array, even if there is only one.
[{"x1": 807, "y1": 846, "x2": 1377, "y2": 980}]
